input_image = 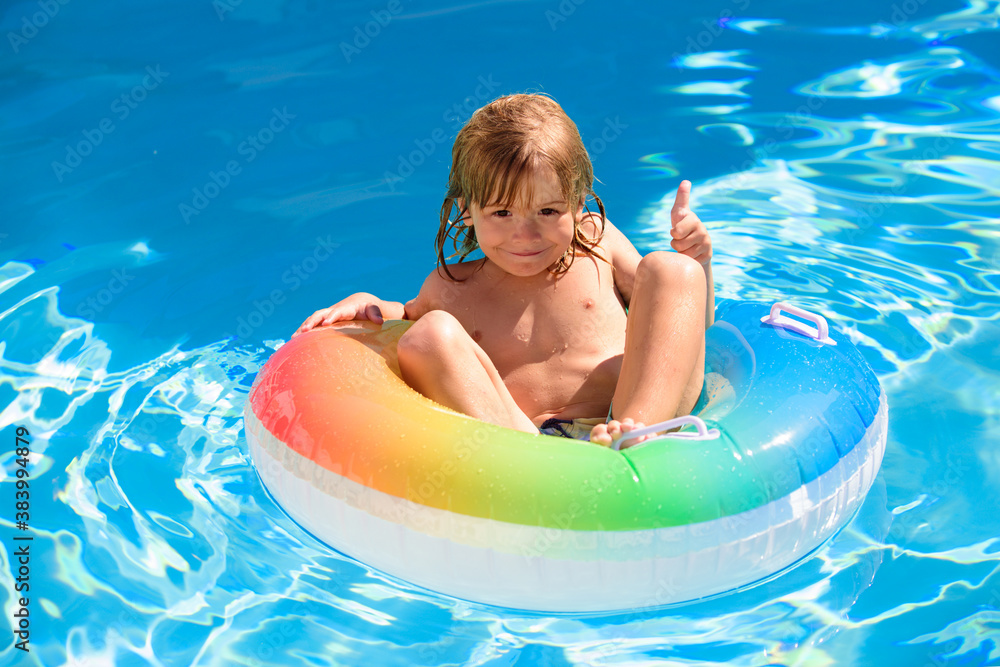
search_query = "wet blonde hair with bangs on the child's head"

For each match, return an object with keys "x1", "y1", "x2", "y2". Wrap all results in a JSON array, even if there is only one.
[{"x1": 434, "y1": 94, "x2": 605, "y2": 280}]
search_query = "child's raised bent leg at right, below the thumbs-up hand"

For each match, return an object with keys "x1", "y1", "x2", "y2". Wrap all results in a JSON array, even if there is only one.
[{"x1": 591, "y1": 252, "x2": 707, "y2": 444}]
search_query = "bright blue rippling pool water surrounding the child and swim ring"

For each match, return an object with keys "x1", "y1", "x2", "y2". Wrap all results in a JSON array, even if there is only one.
[{"x1": 0, "y1": 0, "x2": 1000, "y2": 667}]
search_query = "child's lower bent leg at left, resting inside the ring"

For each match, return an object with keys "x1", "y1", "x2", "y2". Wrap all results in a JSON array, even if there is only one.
[{"x1": 398, "y1": 310, "x2": 538, "y2": 433}]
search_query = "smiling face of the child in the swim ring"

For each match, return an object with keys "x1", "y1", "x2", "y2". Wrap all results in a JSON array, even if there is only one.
[{"x1": 465, "y1": 168, "x2": 583, "y2": 277}]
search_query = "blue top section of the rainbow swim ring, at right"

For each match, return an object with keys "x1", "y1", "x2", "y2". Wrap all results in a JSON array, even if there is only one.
[{"x1": 701, "y1": 302, "x2": 881, "y2": 508}]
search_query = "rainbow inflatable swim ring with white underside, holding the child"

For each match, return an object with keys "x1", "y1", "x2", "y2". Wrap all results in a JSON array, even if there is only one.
[{"x1": 245, "y1": 302, "x2": 887, "y2": 612}]
